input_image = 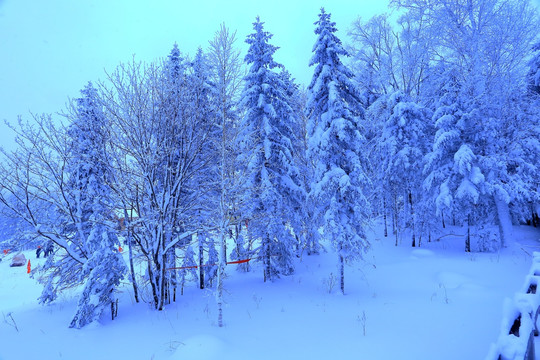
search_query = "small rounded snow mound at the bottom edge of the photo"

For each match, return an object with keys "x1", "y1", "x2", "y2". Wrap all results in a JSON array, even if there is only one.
[{"x1": 170, "y1": 335, "x2": 226, "y2": 360}]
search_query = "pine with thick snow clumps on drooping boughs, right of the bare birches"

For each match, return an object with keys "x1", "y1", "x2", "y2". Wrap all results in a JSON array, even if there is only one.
[{"x1": 423, "y1": 68, "x2": 485, "y2": 252}]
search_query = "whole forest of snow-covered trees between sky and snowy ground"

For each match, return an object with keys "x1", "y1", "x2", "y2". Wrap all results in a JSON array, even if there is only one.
[{"x1": 0, "y1": 0, "x2": 540, "y2": 328}]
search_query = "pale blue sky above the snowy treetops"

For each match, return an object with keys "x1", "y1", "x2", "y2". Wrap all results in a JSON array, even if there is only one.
[{"x1": 0, "y1": 0, "x2": 388, "y2": 148}]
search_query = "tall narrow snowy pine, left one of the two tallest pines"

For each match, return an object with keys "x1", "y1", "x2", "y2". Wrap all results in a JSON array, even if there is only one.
[{"x1": 239, "y1": 17, "x2": 301, "y2": 281}]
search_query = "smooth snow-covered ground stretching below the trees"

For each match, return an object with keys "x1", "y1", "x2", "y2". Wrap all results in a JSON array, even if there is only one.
[{"x1": 0, "y1": 226, "x2": 540, "y2": 360}]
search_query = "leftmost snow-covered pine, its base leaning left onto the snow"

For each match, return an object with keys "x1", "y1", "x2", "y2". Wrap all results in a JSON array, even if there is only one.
[{"x1": 64, "y1": 83, "x2": 126, "y2": 328}]
